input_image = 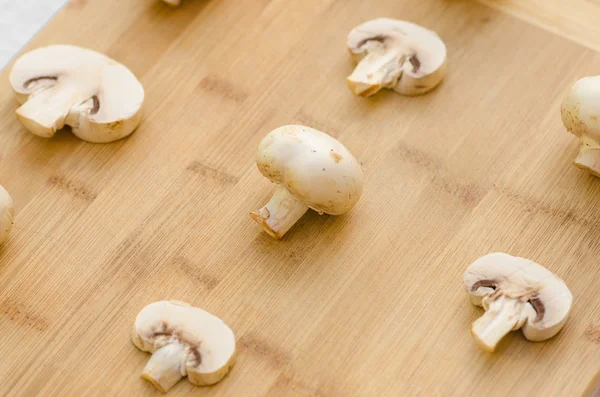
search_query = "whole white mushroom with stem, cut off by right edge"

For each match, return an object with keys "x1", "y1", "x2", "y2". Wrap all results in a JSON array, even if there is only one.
[{"x1": 560, "y1": 76, "x2": 600, "y2": 176}]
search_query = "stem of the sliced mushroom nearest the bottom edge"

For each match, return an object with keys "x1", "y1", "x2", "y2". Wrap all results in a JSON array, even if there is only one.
[{"x1": 142, "y1": 343, "x2": 185, "y2": 393}]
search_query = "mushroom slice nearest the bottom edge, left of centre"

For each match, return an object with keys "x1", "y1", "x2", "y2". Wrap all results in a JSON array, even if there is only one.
[{"x1": 132, "y1": 301, "x2": 235, "y2": 392}]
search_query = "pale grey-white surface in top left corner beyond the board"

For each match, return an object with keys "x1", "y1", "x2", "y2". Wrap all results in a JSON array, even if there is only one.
[{"x1": 0, "y1": 0, "x2": 68, "y2": 70}]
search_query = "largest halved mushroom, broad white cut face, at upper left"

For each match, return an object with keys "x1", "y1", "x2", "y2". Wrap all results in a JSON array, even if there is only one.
[{"x1": 10, "y1": 45, "x2": 144, "y2": 143}]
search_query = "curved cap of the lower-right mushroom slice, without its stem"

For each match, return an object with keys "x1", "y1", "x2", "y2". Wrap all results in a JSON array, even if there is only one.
[{"x1": 463, "y1": 253, "x2": 573, "y2": 341}]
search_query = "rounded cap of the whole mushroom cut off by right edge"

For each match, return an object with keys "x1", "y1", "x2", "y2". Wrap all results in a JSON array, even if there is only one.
[{"x1": 560, "y1": 76, "x2": 600, "y2": 142}]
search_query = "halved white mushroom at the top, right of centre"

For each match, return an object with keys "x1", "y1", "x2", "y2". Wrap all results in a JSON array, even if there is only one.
[{"x1": 347, "y1": 18, "x2": 446, "y2": 96}]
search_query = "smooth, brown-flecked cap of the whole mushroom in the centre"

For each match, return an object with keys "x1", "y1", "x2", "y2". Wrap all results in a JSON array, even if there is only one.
[{"x1": 256, "y1": 125, "x2": 363, "y2": 215}]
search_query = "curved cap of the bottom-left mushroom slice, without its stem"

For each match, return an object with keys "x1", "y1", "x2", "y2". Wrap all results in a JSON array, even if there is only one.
[{"x1": 132, "y1": 301, "x2": 236, "y2": 386}]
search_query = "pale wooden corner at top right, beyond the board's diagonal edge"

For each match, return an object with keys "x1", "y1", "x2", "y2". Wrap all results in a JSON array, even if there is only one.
[{"x1": 477, "y1": 0, "x2": 600, "y2": 51}]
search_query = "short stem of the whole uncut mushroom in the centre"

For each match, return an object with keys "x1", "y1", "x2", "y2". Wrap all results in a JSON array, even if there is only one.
[{"x1": 250, "y1": 185, "x2": 309, "y2": 239}]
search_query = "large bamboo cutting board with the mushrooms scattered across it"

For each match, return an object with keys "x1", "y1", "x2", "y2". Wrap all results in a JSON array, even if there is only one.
[{"x1": 0, "y1": 0, "x2": 600, "y2": 397}]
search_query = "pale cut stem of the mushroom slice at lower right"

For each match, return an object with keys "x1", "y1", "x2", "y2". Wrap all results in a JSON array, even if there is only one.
[{"x1": 471, "y1": 295, "x2": 525, "y2": 352}]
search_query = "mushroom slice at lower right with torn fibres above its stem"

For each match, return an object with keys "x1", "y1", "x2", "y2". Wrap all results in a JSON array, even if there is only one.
[{"x1": 463, "y1": 253, "x2": 573, "y2": 351}]
